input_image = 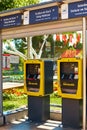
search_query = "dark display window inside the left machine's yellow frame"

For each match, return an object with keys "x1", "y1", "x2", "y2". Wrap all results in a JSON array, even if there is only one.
[{"x1": 26, "y1": 63, "x2": 40, "y2": 92}]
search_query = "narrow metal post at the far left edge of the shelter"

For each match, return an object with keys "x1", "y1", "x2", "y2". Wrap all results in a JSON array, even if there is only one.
[{"x1": 0, "y1": 33, "x2": 3, "y2": 116}]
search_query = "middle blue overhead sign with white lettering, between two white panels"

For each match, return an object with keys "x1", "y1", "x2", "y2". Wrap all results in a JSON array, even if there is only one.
[{"x1": 29, "y1": 6, "x2": 59, "y2": 24}]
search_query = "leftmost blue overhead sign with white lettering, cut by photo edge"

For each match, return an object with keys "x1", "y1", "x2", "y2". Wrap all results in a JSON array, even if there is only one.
[{"x1": 0, "y1": 14, "x2": 22, "y2": 28}]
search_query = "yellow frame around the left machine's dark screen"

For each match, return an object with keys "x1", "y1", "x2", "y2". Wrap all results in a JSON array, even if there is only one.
[{"x1": 24, "y1": 60, "x2": 44, "y2": 96}]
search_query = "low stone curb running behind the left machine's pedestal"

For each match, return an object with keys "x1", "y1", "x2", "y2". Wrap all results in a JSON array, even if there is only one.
[{"x1": 0, "y1": 107, "x2": 62, "y2": 125}]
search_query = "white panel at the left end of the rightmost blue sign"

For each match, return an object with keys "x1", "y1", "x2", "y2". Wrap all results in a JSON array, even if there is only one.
[{"x1": 61, "y1": 4, "x2": 68, "y2": 19}]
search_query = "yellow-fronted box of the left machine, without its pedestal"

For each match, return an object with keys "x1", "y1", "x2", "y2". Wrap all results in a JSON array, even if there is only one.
[{"x1": 24, "y1": 59, "x2": 53, "y2": 96}]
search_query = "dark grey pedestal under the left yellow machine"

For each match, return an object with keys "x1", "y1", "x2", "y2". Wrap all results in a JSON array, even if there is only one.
[{"x1": 28, "y1": 95, "x2": 50, "y2": 122}]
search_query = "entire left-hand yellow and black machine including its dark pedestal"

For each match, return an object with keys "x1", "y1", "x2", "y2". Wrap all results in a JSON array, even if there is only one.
[{"x1": 24, "y1": 59, "x2": 53, "y2": 122}]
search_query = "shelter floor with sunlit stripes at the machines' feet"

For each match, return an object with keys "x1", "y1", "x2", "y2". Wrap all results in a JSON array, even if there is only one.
[{"x1": 0, "y1": 119, "x2": 81, "y2": 130}]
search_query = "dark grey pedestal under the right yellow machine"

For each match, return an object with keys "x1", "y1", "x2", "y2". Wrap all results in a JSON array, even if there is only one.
[{"x1": 62, "y1": 98, "x2": 82, "y2": 128}]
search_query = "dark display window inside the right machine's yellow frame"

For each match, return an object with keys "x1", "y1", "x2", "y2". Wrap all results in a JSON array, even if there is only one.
[{"x1": 60, "y1": 62, "x2": 78, "y2": 93}]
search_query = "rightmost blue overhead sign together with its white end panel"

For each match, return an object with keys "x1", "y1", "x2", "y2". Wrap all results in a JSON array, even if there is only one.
[{"x1": 61, "y1": 1, "x2": 87, "y2": 19}]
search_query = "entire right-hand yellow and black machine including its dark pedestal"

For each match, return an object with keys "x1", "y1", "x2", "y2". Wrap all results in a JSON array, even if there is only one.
[{"x1": 57, "y1": 58, "x2": 83, "y2": 128}]
